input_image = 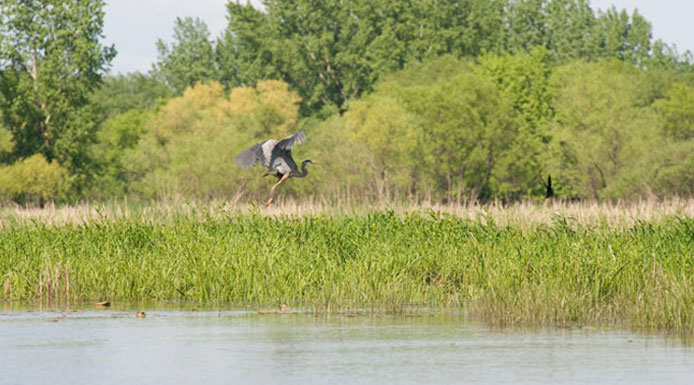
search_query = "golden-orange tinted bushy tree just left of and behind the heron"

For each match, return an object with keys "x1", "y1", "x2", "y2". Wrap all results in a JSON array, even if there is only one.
[{"x1": 125, "y1": 81, "x2": 299, "y2": 197}]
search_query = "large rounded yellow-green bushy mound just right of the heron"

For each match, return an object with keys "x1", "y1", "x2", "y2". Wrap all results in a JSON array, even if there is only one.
[{"x1": 318, "y1": 57, "x2": 517, "y2": 200}]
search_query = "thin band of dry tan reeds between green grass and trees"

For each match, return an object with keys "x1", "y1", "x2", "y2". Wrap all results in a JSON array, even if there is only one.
[{"x1": 0, "y1": 198, "x2": 694, "y2": 229}]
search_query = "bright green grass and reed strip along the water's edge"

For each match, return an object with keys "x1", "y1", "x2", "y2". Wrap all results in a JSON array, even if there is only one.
[{"x1": 0, "y1": 201, "x2": 694, "y2": 332}]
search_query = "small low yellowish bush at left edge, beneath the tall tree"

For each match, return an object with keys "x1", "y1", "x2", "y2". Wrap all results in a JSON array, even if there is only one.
[{"x1": 0, "y1": 154, "x2": 67, "y2": 204}]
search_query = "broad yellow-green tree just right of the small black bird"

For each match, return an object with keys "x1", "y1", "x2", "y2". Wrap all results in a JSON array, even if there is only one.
[{"x1": 549, "y1": 60, "x2": 664, "y2": 199}]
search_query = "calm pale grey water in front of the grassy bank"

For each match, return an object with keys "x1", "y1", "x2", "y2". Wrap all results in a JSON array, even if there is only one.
[{"x1": 0, "y1": 308, "x2": 694, "y2": 385}]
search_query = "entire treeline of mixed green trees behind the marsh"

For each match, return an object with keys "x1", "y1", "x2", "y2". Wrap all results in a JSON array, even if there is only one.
[{"x1": 0, "y1": 0, "x2": 694, "y2": 205}]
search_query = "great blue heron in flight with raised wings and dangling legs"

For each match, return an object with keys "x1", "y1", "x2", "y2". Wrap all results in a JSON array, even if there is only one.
[{"x1": 236, "y1": 131, "x2": 313, "y2": 206}]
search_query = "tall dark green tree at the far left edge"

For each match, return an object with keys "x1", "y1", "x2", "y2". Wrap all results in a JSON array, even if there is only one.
[{"x1": 0, "y1": 0, "x2": 116, "y2": 180}]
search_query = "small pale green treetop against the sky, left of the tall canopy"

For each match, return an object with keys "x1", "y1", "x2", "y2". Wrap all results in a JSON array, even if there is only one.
[{"x1": 153, "y1": 17, "x2": 217, "y2": 93}]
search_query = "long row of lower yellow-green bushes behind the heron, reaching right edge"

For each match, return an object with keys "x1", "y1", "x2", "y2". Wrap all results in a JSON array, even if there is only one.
[{"x1": 88, "y1": 56, "x2": 694, "y2": 202}]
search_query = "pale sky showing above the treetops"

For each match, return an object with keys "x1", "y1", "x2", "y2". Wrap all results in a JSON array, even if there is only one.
[{"x1": 104, "y1": 0, "x2": 694, "y2": 73}]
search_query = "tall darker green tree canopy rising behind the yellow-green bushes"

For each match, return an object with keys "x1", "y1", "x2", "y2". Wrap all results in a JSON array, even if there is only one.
[{"x1": 216, "y1": 0, "x2": 692, "y2": 112}]
